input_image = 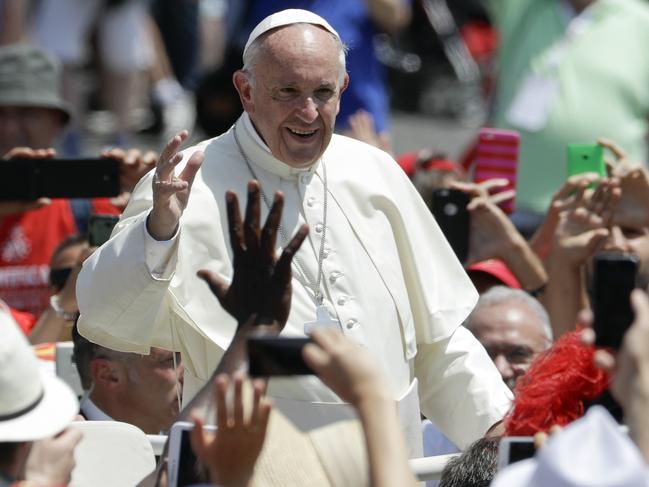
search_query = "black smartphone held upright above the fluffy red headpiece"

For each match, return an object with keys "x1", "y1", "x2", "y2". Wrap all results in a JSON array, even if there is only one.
[{"x1": 591, "y1": 252, "x2": 638, "y2": 350}]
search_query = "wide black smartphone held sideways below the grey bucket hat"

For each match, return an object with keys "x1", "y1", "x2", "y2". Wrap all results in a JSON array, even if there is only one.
[{"x1": 0, "y1": 158, "x2": 120, "y2": 201}]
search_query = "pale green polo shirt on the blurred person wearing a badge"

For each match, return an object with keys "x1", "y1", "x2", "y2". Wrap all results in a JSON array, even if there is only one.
[{"x1": 491, "y1": 0, "x2": 649, "y2": 212}]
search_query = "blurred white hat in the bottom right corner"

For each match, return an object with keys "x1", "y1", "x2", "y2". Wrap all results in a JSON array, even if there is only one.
[{"x1": 491, "y1": 406, "x2": 649, "y2": 487}]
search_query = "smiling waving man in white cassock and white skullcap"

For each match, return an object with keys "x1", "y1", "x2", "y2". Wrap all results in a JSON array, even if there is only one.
[{"x1": 77, "y1": 10, "x2": 511, "y2": 451}]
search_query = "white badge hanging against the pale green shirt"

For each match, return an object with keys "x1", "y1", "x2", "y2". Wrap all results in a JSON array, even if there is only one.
[{"x1": 507, "y1": 74, "x2": 559, "y2": 132}]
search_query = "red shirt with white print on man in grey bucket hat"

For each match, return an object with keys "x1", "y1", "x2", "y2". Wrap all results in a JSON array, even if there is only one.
[{"x1": 0, "y1": 198, "x2": 120, "y2": 316}]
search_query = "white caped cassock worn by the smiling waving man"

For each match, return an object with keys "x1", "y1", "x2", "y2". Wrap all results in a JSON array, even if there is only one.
[{"x1": 77, "y1": 114, "x2": 511, "y2": 454}]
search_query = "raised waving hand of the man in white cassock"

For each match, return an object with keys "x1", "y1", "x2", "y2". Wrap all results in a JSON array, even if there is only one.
[{"x1": 147, "y1": 130, "x2": 204, "y2": 240}]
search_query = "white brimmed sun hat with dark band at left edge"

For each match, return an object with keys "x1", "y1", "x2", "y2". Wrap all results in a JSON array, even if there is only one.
[{"x1": 0, "y1": 304, "x2": 79, "y2": 442}]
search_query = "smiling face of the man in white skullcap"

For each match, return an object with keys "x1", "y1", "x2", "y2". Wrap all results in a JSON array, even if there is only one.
[{"x1": 234, "y1": 24, "x2": 348, "y2": 167}]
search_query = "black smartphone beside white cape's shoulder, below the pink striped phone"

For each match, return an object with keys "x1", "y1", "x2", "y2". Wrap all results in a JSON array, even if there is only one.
[{"x1": 431, "y1": 188, "x2": 470, "y2": 264}]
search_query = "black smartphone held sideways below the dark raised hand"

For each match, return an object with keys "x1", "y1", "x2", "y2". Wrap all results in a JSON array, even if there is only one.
[{"x1": 247, "y1": 337, "x2": 313, "y2": 377}]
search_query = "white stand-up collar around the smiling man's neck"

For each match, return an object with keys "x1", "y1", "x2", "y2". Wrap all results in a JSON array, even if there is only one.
[{"x1": 234, "y1": 112, "x2": 320, "y2": 179}]
